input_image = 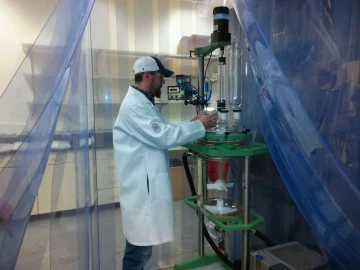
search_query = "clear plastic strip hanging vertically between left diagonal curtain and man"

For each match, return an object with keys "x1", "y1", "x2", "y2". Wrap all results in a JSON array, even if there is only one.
[{"x1": 48, "y1": 24, "x2": 100, "y2": 269}]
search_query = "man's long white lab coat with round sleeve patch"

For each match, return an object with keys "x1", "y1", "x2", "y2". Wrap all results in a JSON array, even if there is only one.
[{"x1": 113, "y1": 87, "x2": 205, "y2": 246}]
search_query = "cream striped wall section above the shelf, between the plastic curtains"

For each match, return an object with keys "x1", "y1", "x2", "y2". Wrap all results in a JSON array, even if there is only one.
[{"x1": 91, "y1": 0, "x2": 212, "y2": 54}]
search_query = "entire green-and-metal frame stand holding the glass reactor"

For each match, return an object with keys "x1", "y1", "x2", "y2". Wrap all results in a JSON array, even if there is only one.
[{"x1": 174, "y1": 32, "x2": 268, "y2": 270}]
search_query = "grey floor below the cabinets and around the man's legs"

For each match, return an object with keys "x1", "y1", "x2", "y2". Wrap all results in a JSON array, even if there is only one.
[{"x1": 16, "y1": 201, "x2": 218, "y2": 270}]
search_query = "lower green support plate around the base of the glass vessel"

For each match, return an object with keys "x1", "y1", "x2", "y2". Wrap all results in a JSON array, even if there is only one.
[{"x1": 185, "y1": 196, "x2": 264, "y2": 231}]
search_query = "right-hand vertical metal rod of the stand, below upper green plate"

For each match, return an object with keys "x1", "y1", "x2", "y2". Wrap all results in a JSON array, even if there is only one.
[{"x1": 241, "y1": 157, "x2": 250, "y2": 270}]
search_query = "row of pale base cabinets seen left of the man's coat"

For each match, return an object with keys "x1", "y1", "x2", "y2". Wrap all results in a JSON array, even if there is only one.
[{"x1": 37, "y1": 148, "x2": 119, "y2": 214}]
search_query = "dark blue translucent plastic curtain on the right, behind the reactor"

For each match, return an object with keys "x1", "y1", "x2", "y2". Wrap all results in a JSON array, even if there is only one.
[{"x1": 233, "y1": 0, "x2": 360, "y2": 269}]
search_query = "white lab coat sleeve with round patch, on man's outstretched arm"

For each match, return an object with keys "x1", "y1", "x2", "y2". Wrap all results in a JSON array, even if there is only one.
[{"x1": 114, "y1": 104, "x2": 205, "y2": 149}]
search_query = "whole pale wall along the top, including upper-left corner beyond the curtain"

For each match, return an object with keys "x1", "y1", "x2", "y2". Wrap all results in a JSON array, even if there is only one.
[{"x1": 0, "y1": 0, "x2": 230, "y2": 103}]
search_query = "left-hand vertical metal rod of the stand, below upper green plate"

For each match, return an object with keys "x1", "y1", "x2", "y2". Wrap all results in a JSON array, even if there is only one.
[{"x1": 196, "y1": 157, "x2": 204, "y2": 257}]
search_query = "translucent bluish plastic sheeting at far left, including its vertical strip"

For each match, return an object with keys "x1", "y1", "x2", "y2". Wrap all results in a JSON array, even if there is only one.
[{"x1": 0, "y1": 0, "x2": 98, "y2": 269}]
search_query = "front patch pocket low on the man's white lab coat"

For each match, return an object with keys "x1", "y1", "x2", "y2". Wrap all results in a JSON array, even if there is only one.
[{"x1": 149, "y1": 173, "x2": 172, "y2": 201}]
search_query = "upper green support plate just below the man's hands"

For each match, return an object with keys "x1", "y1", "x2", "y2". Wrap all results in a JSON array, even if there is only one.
[{"x1": 182, "y1": 142, "x2": 268, "y2": 157}]
